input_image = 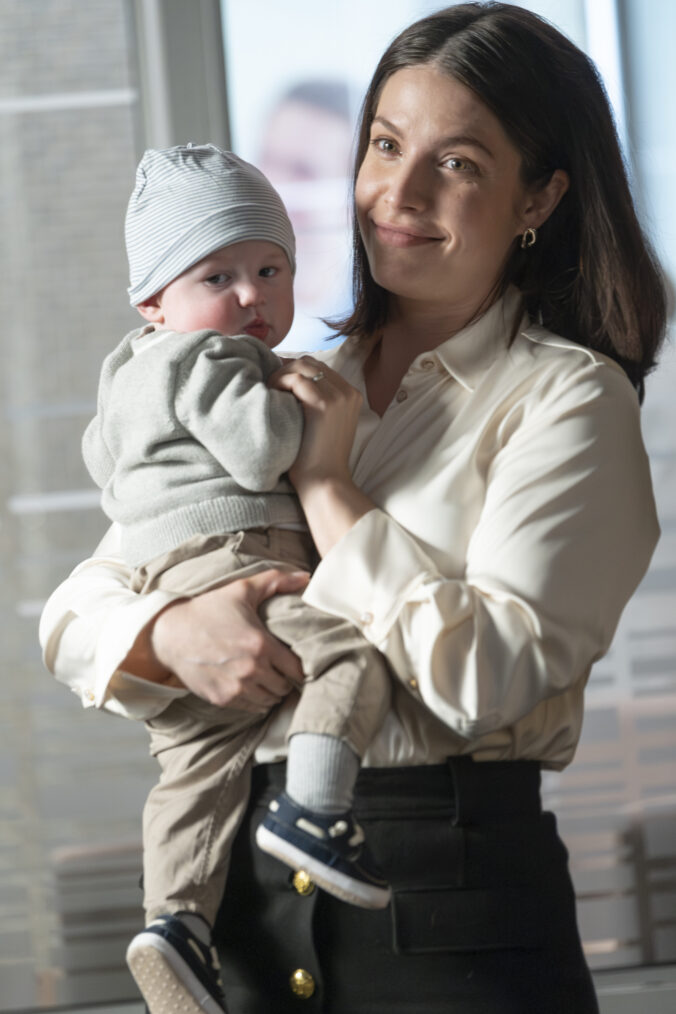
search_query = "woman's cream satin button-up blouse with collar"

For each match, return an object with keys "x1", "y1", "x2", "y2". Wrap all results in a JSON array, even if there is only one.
[{"x1": 41, "y1": 290, "x2": 659, "y2": 769}]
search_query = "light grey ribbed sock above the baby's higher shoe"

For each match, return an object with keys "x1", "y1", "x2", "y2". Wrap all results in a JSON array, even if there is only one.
[{"x1": 287, "y1": 732, "x2": 360, "y2": 813}]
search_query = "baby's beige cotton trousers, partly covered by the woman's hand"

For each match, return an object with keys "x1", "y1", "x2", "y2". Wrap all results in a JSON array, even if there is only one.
[{"x1": 132, "y1": 528, "x2": 390, "y2": 925}]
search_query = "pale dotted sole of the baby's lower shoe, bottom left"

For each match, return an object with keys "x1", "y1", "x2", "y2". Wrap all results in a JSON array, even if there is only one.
[{"x1": 127, "y1": 933, "x2": 226, "y2": 1014}]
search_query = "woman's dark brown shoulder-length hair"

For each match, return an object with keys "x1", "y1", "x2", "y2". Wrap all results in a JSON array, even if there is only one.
[{"x1": 332, "y1": 3, "x2": 667, "y2": 399}]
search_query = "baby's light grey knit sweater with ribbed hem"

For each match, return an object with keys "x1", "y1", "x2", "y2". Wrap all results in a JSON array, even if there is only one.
[{"x1": 82, "y1": 324, "x2": 303, "y2": 566}]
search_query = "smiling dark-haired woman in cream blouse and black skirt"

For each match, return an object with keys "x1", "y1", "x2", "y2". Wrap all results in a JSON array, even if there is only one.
[{"x1": 43, "y1": 4, "x2": 665, "y2": 1014}]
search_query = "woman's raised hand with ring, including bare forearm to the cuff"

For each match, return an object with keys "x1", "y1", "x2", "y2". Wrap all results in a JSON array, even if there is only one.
[{"x1": 268, "y1": 356, "x2": 375, "y2": 557}]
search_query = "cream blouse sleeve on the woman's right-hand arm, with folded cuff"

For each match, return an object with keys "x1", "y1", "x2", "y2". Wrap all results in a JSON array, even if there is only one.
[{"x1": 305, "y1": 361, "x2": 659, "y2": 739}]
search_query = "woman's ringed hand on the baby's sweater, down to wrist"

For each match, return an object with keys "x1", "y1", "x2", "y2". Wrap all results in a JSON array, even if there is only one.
[{"x1": 268, "y1": 356, "x2": 363, "y2": 498}]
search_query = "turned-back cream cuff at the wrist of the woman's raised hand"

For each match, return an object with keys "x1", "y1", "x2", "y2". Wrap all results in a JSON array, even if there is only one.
[{"x1": 303, "y1": 508, "x2": 442, "y2": 646}]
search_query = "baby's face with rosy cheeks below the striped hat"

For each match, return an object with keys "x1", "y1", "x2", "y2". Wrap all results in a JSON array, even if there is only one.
[{"x1": 139, "y1": 239, "x2": 294, "y2": 349}]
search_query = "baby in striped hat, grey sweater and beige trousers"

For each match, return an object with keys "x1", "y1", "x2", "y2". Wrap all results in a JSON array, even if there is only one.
[{"x1": 82, "y1": 145, "x2": 390, "y2": 1014}]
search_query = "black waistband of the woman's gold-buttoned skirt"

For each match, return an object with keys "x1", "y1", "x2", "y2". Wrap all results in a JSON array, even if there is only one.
[{"x1": 251, "y1": 756, "x2": 542, "y2": 826}]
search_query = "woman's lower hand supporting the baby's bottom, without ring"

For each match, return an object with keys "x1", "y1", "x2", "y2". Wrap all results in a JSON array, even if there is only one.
[{"x1": 146, "y1": 570, "x2": 309, "y2": 712}]
